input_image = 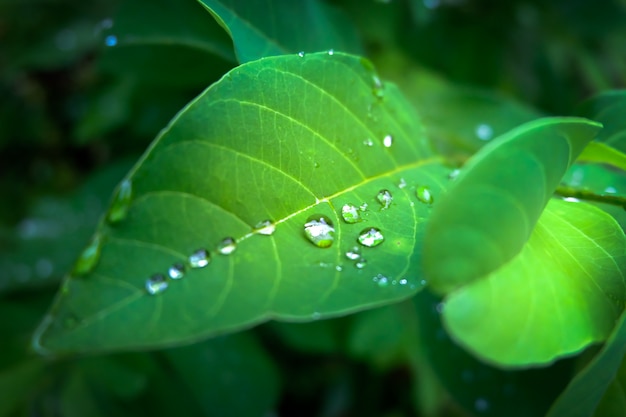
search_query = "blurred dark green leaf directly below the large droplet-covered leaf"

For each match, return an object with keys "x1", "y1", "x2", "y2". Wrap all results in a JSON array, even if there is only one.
[{"x1": 165, "y1": 333, "x2": 280, "y2": 417}]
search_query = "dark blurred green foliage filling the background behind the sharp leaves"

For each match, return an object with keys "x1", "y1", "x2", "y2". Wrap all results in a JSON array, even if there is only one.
[{"x1": 0, "y1": 0, "x2": 626, "y2": 417}]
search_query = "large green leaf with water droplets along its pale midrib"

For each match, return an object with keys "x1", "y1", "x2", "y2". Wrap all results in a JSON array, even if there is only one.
[{"x1": 35, "y1": 53, "x2": 449, "y2": 352}]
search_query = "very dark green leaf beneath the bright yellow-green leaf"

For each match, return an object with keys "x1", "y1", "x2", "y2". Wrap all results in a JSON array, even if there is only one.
[{"x1": 413, "y1": 291, "x2": 573, "y2": 417}]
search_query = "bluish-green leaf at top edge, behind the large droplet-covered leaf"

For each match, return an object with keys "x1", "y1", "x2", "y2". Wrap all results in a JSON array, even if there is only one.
[{"x1": 199, "y1": 0, "x2": 362, "y2": 63}]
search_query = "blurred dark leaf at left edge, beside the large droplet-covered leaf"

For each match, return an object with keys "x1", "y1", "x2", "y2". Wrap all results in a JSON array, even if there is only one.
[{"x1": 0, "y1": 161, "x2": 132, "y2": 295}]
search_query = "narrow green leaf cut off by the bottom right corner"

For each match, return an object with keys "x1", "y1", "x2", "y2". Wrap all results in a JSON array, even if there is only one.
[{"x1": 547, "y1": 314, "x2": 626, "y2": 417}]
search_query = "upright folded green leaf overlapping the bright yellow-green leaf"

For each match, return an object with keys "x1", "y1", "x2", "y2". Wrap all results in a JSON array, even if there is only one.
[{"x1": 423, "y1": 118, "x2": 600, "y2": 294}]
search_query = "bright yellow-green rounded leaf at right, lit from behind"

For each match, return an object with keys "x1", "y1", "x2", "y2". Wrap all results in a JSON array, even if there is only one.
[{"x1": 443, "y1": 200, "x2": 626, "y2": 367}]
